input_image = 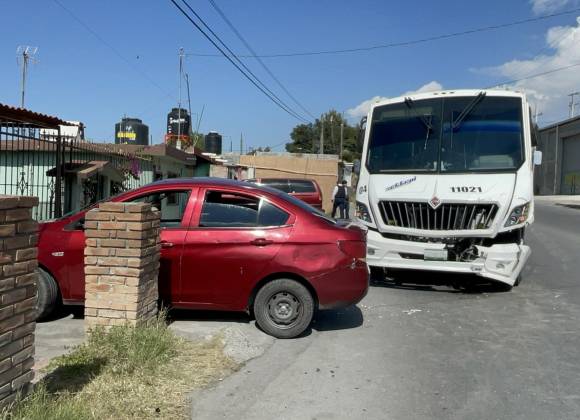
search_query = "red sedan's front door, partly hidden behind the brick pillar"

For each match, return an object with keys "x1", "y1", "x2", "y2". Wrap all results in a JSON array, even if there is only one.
[{"x1": 122, "y1": 188, "x2": 197, "y2": 303}]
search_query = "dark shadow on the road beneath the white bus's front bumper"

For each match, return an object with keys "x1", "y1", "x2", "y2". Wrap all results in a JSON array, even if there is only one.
[{"x1": 370, "y1": 270, "x2": 511, "y2": 294}]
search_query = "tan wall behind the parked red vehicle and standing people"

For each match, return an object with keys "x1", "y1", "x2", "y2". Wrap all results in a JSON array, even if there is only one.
[{"x1": 240, "y1": 155, "x2": 338, "y2": 212}]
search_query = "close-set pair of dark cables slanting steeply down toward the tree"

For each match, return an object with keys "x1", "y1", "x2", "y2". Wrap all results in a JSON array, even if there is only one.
[{"x1": 170, "y1": 0, "x2": 308, "y2": 122}]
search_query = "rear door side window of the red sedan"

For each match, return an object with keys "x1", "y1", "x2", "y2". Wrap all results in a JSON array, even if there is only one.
[{"x1": 199, "y1": 191, "x2": 289, "y2": 228}]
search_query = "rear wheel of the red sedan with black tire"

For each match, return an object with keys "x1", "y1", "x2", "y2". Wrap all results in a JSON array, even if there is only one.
[{"x1": 254, "y1": 279, "x2": 314, "y2": 338}]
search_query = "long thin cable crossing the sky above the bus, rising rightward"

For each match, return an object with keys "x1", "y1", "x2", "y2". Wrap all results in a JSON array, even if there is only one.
[{"x1": 188, "y1": 7, "x2": 580, "y2": 58}]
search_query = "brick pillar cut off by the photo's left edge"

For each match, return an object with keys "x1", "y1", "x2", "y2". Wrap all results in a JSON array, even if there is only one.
[{"x1": 0, "y1": 195, "x2": 38, "y2": 408}]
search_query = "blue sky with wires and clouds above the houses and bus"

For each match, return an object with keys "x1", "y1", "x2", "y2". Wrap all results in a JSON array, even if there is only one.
[{"x1": 0, "y1": 0, "x2": 580, "y2": 150}]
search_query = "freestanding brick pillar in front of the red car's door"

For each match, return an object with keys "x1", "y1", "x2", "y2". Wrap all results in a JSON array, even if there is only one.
[{"x1": 85, "y1": 202, "x2": 161, "y2": 330}]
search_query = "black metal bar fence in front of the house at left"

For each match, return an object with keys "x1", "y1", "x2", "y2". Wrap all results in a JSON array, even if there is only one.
[{"x1": 0, "y1": 116, "x2": 155, "y2": 220}]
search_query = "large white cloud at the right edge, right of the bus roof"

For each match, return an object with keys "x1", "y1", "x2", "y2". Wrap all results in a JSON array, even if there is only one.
[{"x1": 487, "y1": 17, "x2": 580, "y2": 123}]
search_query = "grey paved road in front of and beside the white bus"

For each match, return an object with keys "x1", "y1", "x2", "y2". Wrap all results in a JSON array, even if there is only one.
[{"x1": 192, "y1": 204, "x2": 580, "y2": 420}]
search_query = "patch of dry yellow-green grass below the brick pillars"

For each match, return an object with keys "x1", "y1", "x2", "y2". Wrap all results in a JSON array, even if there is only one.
[{"x1": 0, "y1": 319, "x2": 237, "y2": 420}]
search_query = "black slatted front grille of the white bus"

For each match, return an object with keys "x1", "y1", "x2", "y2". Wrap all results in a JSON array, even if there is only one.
[{"x1": 379, "y1": 201, "x2": 498, "y2": 231}]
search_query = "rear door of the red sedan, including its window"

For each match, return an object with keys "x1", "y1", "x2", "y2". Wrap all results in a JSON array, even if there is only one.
[{"x1": 182, "y1": 188, "x2": 293, "y2": 309}]
